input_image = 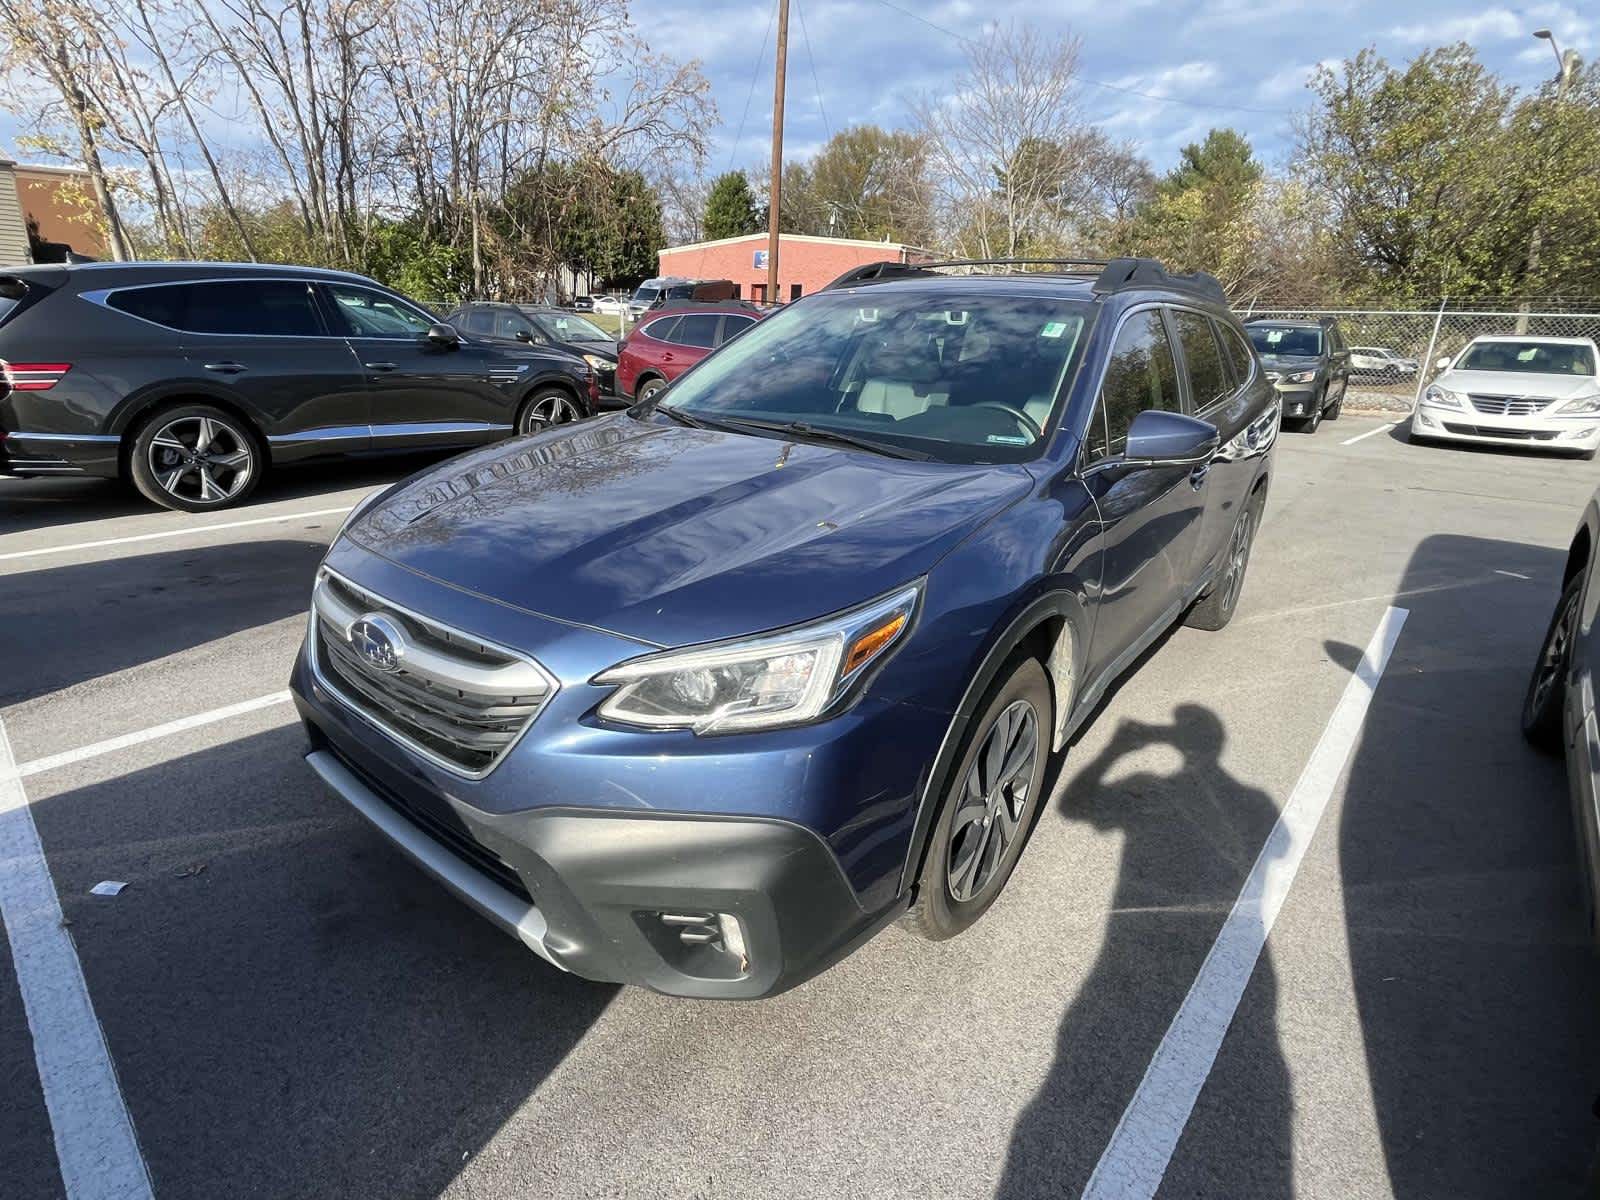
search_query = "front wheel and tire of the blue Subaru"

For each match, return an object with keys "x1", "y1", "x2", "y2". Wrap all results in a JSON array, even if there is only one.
[{"x1": 904, "y1": 658, "x2": 1054, "y2": 941}]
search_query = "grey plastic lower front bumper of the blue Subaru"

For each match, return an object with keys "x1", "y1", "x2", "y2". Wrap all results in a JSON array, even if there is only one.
[{"x1": 296, "y1": 691, "x2": 904, "y2": 1000}]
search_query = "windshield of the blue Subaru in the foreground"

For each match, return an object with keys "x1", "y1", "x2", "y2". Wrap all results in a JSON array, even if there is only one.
[{"x1": 661, "y1": 288, "x2": 1090, "y2": 462}]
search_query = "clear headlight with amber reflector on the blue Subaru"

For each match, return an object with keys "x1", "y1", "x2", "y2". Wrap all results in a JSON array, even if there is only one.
[{"x1": 594, "y1": 582, "x2": 922, "y2": 733}]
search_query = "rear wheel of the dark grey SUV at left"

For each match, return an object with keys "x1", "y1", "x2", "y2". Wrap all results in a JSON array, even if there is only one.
[{"x1": 128, "y1": 403, "x2": 267, "y2": 512}]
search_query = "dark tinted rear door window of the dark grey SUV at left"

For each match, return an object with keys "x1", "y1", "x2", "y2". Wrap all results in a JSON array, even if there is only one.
[{"x1": 106, "y1": 280, "x2": 325, "y2": 338}]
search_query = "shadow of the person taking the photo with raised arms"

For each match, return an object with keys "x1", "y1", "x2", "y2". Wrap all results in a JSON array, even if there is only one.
[{"x1": 995, "y1": 704, "x2": 1293, "y2": 1200}]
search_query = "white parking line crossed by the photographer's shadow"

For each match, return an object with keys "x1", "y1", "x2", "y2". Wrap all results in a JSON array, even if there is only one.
[{"x1": 1083, "y1": 608, "x2": 1406, "y2": 1200}]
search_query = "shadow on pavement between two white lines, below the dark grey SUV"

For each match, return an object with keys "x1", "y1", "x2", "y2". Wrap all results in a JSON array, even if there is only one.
[{"x1": 0, "y1": 540, "x2": 328, "y2": 706}]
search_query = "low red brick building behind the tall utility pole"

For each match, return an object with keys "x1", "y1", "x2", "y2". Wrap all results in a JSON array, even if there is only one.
[{"x1": 658, "y1": 234, "x2": 936, "y2": 301}]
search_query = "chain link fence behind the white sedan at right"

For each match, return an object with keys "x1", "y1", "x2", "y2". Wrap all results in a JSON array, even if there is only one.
[{"x1": 1238, "y1": 304, "x2": 1600, "y2": 411}]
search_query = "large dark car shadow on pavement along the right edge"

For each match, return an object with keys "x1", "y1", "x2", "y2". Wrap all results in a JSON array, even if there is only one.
[{"x1": 1320, "y1": 537, "x2": 1600, "y2": 1197}]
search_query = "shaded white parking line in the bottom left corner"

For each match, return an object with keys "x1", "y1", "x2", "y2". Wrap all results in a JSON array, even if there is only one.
[{"x1": 0, "y1": 722, "x2": 152, "y2": 1200}]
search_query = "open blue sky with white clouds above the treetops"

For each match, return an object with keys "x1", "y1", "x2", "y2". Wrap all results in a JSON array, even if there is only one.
[{"x1": 646, "y1": 0, "x2": 1600, "y2": 174}]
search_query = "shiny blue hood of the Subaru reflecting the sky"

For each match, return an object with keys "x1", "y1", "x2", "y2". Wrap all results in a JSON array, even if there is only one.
[{"x1": 347, "y1": 414, "x2": 1032, "y2": 646}]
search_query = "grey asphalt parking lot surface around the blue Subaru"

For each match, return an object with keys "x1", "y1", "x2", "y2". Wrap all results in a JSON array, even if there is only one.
[{"x1": 0, "y1": 414, "x2": 1600, "y2": 1198}]
